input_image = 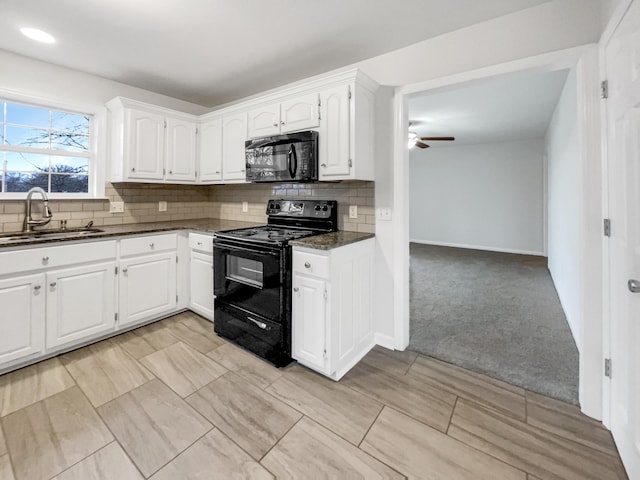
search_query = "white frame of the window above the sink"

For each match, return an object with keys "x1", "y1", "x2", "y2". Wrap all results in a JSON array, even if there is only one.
[{"x1": 0, "y1": 88, "x2": 107, "y2": 202}]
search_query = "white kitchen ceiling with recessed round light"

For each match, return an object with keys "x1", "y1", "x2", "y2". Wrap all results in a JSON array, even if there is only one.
[{"x1": 0, "y1": 0, "x2": 550, "y2": 107}]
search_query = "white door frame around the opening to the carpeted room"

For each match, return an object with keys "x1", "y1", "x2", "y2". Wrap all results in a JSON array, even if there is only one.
[{"x1": 391, "y1": 44, "x2": 603, "y2": 419}]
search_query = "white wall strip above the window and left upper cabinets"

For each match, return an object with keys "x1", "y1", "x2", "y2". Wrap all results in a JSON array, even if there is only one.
[{"x1": 0, "y1": 50, "x2": 210, "y2": 114}]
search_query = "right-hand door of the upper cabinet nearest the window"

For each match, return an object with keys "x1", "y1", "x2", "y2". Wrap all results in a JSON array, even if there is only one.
[{"x1": 165, "y1": 117, "x2": 196, "y2": 182}]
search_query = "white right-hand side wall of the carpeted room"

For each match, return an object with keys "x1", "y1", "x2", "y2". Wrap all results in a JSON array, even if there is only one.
[{"x1": 545, "y1": 69, "x2": 582, "y2": 348}]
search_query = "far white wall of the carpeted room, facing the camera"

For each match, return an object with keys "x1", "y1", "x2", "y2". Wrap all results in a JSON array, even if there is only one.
[{"x1": 409, "y1": 138, "x2": 545, "y2": 255}]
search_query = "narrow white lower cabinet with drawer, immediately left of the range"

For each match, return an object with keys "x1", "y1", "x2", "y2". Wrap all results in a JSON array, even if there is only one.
[{"x1": 189, "y1": 233, "x2": 213, "y2": 321}]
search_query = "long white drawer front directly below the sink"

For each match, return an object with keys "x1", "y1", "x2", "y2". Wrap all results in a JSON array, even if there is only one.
[{"x1": 0, "y1": 240, "x2": 116, "y2": 275}]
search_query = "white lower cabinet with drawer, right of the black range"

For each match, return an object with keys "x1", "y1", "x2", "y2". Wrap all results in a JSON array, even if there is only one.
[{"x1": 291, "y1": 238, "x2": 375, "y2": 380}]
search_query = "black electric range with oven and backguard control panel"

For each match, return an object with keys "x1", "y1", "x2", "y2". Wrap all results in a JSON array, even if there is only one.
[{"x1": 213, "y1": 199, "x2": 338, "y2": 366}]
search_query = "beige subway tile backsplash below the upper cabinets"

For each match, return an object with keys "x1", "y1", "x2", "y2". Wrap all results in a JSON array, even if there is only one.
[{"x1": 0, "y1": 181, "x2": 375, "y2": 232}]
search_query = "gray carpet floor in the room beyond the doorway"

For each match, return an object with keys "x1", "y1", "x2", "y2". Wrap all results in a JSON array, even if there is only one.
[{"x1": 409, "y1": 243, "x2": 578, "y2": 404}]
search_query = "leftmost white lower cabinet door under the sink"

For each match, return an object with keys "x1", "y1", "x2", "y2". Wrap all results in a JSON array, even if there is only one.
[{"x1": 0, "y1": 274, "x2": 46, "y2": 365}]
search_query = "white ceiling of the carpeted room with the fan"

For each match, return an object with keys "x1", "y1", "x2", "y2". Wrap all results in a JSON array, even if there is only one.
[{"x1": 409, "y1": 66, "x2": 568, "y2": 147}]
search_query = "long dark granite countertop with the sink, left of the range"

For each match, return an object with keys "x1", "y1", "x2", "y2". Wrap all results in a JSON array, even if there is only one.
[{"x1": 0, "y1": 219, "x2": 262, "y2": 249}]
